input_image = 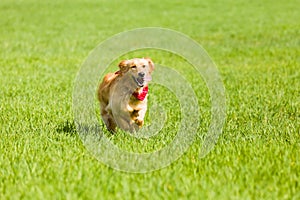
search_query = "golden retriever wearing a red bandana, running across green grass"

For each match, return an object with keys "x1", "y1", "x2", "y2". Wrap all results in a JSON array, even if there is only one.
[{"x1": 98, "y1": 58, "x2": 154, "y2": 132}]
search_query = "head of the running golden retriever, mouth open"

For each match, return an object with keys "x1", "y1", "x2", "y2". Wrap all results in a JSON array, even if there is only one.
[{"x1": 119, "y1": 58, "x2": 154, "y2": 87}]
